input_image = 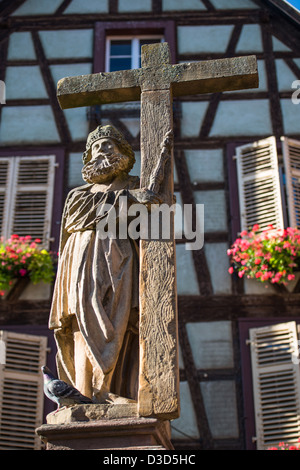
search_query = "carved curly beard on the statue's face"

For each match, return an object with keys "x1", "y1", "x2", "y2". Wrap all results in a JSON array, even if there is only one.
[{"x1": 81, "y1": 153, "x2": 129, "y2": 184}]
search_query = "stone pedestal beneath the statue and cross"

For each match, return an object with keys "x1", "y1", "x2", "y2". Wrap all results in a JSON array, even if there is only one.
[{"x1": 36, "y1": 404, "x2": 174, "y2": 451}]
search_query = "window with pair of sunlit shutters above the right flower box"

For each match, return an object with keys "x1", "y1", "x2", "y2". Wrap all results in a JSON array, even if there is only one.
[{"x1": 228, "y1": 137, "x2": 300, "y2": 238}]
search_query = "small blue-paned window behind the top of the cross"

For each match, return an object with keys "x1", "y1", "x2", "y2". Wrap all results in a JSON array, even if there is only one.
[{"x1": 105, "y1": 35, "x2": 163, "y2": 72}]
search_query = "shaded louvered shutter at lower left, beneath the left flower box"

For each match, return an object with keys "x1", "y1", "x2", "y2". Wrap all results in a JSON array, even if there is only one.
[{"x1": 0, "y1": 331, "x2": 47, "y2": 450}]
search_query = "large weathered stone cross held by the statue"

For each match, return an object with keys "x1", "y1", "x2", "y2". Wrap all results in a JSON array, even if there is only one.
[{"x1": 57, "y1": 43, "x2": 258, "y2": 419}]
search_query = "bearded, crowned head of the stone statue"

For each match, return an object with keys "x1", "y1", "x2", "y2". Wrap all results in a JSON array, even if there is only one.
[{"x1": 82, "y1": 126, "x2": 135, "y2": 183}]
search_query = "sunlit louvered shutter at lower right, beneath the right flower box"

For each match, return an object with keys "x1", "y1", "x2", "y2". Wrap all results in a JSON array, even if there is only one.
[{"x1": 250, "y1": 322, "x2": 300, "y2": 450}]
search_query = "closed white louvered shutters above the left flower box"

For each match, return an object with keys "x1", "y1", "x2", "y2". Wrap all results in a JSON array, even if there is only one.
[{"x1": 0, "y1": 155, "x2": 55, "y2": 248}]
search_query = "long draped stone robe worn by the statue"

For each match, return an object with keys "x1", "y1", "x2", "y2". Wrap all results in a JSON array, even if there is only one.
[{"x1": 49, "y1": 177, "x2": 139, "y2": 398}]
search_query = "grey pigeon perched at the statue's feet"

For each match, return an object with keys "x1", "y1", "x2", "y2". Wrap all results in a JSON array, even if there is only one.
[{"x1": 41, "y1": 366, "x2": 93, "y2": 411}]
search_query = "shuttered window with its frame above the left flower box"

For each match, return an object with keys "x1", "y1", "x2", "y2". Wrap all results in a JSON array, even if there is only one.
[{"x1": 0, "y1": 152, "x2": 63, "y2": 252}]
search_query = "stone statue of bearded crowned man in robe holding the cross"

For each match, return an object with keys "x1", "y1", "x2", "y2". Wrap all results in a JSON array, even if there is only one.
[{"x1": 49, "y1": 126, "x2": 160, "y2": 403}]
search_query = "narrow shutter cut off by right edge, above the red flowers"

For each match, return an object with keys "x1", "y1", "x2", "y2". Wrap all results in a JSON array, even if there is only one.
[{"x1": 281, "y1": 137, "x2": 300, "y2": 228}]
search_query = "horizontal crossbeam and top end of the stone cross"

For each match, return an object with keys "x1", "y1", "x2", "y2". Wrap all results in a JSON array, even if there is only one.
[{"x1": 57, "y1": 43, "x2": 258, "y2": 109}]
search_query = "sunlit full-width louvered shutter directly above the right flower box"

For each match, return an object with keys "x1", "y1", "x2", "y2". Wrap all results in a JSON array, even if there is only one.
[{"x1": 236, "y1": 137, "x2": 283, "y2": 230}]
